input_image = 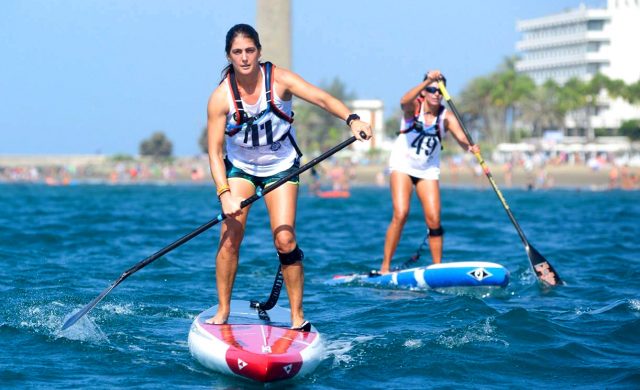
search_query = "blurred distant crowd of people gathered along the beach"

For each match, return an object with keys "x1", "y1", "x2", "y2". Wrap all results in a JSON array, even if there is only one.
[{"x1": 0, "y1": 152, "x2": 640, "y2": 191}]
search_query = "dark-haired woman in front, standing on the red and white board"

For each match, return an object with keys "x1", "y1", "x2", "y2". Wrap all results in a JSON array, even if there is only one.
[{"x1": 207, "y1": 24, "x2": 371, "y2": 331}]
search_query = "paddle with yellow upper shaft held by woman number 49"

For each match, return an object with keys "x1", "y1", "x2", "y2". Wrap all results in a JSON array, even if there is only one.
[{"x1": 438, "y1": 80, "x2": 564, "y2": 286}]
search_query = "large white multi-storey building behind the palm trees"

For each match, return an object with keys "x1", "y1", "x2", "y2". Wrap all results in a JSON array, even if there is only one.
[{"x1": 516, "y1": 0, "x2": 640, "y2": 138}]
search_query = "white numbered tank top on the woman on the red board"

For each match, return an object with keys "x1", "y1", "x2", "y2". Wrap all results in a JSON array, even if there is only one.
[{"x1": 225, "y1": 67, "x2": 298, "y2": 177}]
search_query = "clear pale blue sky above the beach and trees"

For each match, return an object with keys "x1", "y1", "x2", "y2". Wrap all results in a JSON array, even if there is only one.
[{"x1": 0, "y1": 0, "x2": 606, "y2": 155}]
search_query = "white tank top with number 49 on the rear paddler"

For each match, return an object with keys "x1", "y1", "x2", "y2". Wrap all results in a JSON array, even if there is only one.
[{"x1": 389, "y1": 103, "x2": 447, "y2": 180}]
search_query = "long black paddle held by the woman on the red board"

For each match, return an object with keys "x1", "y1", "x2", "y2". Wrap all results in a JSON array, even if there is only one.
[{"x1": 62, "y1": 132, "x2": 366, "y2": 330}]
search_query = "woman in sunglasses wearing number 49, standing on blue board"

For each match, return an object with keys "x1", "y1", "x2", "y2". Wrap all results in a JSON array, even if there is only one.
[{"x1": 380, "y1": 70, "x2": 479, "y2": 274}]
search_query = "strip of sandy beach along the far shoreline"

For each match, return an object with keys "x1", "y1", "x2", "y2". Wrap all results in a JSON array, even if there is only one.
[{"x1": 0, "y1": 155, "x2": 640, "y2": 190}]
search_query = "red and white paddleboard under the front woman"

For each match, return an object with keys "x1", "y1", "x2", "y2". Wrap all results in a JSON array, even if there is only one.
[{"x1": 189, "y1": 300, "x2": 323, "y2": 382}]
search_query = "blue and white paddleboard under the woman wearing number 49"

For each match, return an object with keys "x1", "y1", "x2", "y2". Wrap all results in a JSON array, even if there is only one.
[{"x1": 329, "y1": 261, "x2": 509, "y2": 288}]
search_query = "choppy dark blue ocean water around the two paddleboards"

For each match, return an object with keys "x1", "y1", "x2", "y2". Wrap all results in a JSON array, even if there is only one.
[{"x1": 0, "y1": 185, "x2": 640, "y2": 389}]
